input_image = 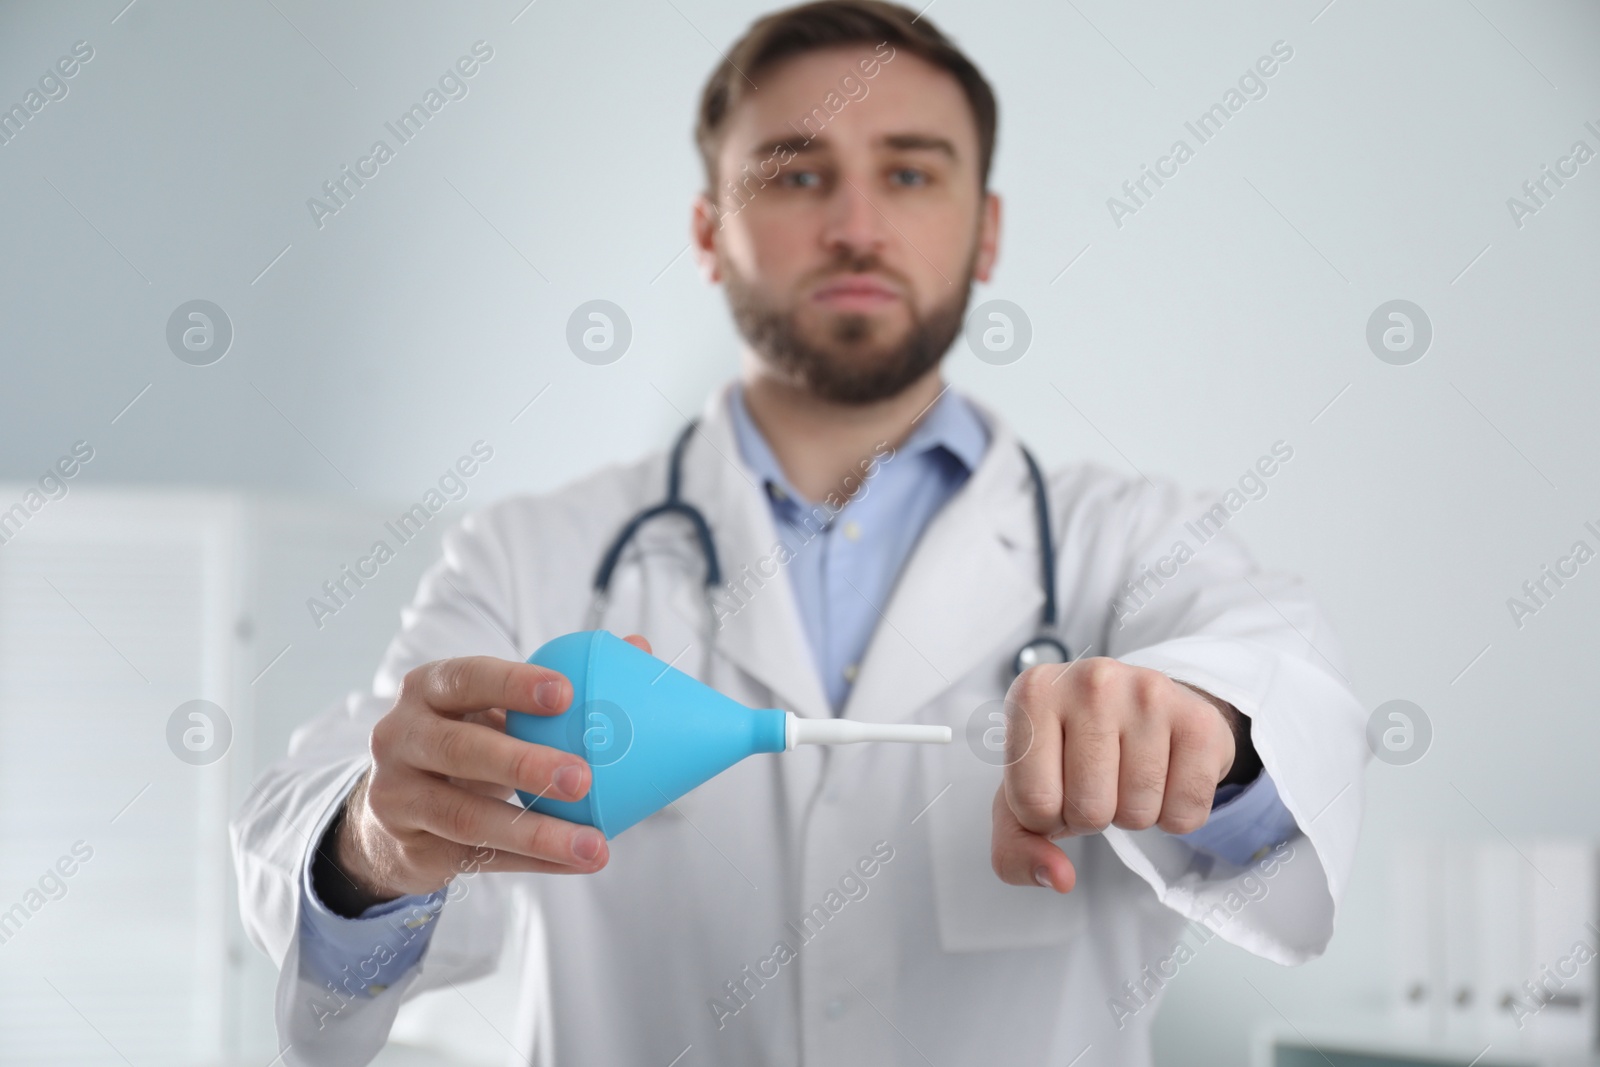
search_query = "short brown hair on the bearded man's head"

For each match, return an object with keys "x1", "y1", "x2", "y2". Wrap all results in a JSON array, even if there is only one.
[{"x1": 694, "y1": 0, "x2": 998, "y2": 195}]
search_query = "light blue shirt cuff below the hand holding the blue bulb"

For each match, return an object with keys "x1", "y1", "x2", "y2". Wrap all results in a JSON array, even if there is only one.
[{"x1": 299, "y1": 830, "x2": 445, "y2": 997}]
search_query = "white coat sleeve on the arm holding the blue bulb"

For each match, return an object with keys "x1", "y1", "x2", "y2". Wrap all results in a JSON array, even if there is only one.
[{"x1": 229, "y1": 512, "x2": 523, "y2": 1065}]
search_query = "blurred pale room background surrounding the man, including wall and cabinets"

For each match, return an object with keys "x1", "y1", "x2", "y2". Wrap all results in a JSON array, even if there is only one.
[{"x1": 0, "y1": 0, "x2": 1600, "y2": 1067}]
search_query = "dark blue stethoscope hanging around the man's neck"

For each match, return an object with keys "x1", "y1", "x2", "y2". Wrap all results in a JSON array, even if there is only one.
[{"x1": 589, "y1": 419, "x2": 1072, "y2": 675}]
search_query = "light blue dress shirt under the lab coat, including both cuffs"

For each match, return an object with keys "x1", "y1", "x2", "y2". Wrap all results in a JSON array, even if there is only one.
[{"x1": 301, "y1": 386, "x2": 1296, "y2": 993}]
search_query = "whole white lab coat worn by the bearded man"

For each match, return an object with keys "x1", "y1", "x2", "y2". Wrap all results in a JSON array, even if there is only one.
[{"x1": 232, "y1": 383, "x2": 1366, "y2": 1067}]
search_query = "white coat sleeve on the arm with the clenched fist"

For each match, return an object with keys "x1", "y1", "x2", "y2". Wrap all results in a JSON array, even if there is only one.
[{"x1": 1102, "y1": 467, "x2": 1368, "y2": 965}]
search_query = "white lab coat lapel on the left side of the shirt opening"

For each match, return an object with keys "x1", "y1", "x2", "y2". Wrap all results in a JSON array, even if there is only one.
[{"x1": 675, "y1": 384, "x2": 832, "y2": 718}]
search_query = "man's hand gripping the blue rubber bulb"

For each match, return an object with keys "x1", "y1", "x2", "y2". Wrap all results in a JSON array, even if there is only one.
[{"x1": 312, "y1": 635, "x2": 650, "y2": 917}]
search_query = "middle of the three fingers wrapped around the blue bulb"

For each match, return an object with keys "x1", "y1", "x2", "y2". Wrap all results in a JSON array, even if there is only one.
[{"x1": 398, "y1": 717, "x2": 590, "y2": 800}]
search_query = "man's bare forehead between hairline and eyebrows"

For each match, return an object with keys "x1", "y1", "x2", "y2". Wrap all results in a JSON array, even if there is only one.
[{"x1": 722, "y1": 45, "x2": 978, "y2": 165}]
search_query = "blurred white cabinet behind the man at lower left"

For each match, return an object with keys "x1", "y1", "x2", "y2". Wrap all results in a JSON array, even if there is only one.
[{"x1": 0, "y1": 485, "x2": 509, "y2": 1067}]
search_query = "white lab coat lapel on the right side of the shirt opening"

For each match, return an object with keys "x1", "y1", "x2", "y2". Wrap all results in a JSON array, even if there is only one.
[{"x1": 843, "y1": 403, "x2": 1043, "y2": 721}]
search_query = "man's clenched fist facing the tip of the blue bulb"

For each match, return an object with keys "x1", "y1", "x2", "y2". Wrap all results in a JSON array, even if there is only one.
[{"x1": 990, "y1": 657, "x2": 1261, "y2": 893}]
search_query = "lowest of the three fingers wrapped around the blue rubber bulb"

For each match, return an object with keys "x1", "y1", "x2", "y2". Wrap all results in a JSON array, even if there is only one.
[{"x1": 406, "y1": 776, "x2": 610, "y2": 870}]
